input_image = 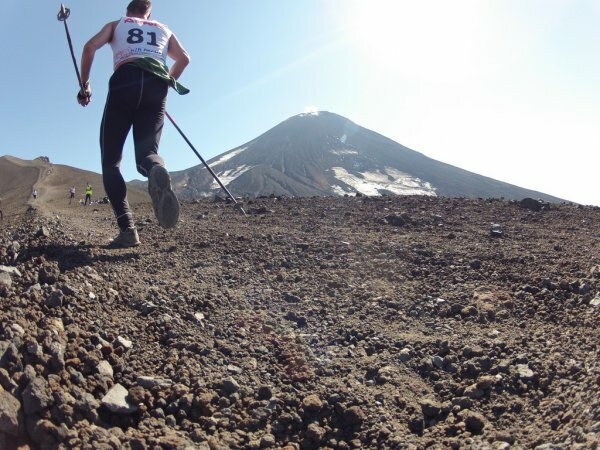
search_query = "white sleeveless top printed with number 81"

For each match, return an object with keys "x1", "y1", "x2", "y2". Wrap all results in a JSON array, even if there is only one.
[{"x1": 110, "y1": 17, "x2": 173, "y2": 68}]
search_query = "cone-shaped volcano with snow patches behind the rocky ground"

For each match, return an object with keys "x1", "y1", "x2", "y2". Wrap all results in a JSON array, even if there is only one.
[{"x1": 172, "y1": 112, "x2": 562, "y2": 202}]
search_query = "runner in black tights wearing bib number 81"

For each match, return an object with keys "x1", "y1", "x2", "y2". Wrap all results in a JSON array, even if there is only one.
[{"x1": 77, "y1": 0, "x2": 190, "y2": 247}]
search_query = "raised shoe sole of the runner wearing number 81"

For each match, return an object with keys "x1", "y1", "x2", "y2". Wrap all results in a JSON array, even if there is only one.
[{"x1": 148, "y1": 166, "x2": 179, "y2": 228}]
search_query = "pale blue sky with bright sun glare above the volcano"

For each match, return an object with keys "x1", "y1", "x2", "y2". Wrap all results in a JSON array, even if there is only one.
[{"x1": 0, "y1": 0, "x2": 600, "y2": 205}]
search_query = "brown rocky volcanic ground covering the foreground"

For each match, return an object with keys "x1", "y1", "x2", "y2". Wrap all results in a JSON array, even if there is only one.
[{"x1": 0, "y1": 197, "x2": 600, "y2": 450}]
